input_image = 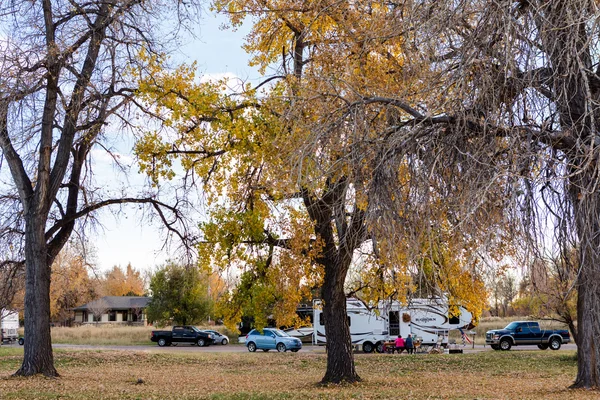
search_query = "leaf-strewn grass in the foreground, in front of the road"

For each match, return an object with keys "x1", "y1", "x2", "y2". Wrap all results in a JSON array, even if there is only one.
[{"x1": 0, "y1": 347, "x2": 599, "y2": 400}]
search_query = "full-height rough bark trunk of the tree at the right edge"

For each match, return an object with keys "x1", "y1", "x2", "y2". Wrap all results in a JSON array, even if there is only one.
[{"x1": 536, "y1": 1, "x2": 600, "y2": 389}]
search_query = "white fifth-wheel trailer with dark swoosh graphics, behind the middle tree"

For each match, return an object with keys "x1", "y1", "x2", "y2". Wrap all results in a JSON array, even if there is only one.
[{"x1": 313, "y1": 298, "x2": 472, "y2": 353}]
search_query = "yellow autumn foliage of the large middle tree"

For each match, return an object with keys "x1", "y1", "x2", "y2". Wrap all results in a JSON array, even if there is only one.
[{"x1": 136, "y1": 0, "x2": 494, "y2": 326}]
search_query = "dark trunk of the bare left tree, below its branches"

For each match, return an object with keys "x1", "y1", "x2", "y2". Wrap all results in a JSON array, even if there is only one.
[{"x1": 15, "y1": 215, "x2": 59, "y2": 377}]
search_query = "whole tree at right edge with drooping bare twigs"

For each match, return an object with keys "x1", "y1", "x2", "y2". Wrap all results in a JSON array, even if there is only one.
[{"x1": 394, "y1": 0, "x2": 600, "y2": 389}]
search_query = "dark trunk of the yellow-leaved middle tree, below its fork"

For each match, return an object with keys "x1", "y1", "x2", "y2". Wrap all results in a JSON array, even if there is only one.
[{"x1": 322, "y1": 262, "x2": 361, "y2": 384}]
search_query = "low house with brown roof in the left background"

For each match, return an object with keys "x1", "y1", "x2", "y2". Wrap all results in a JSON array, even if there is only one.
[{"x1": 73, "y1": 296, "x2": 150, "y2": 325}]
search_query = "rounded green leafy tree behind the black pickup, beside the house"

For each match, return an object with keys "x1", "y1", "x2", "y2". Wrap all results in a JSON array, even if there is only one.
[{"x1": 146, "y1": 263, "x2": 212, "y2": 325}]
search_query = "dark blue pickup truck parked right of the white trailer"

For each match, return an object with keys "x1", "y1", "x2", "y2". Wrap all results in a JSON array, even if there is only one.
[{"x1": 485, "y1": 321, "x2": 571, "y2": 350}]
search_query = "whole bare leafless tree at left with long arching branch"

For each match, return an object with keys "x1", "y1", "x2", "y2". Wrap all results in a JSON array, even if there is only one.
[{"x1": 0, "y1": 0, "x2": 197, "y2": 376}]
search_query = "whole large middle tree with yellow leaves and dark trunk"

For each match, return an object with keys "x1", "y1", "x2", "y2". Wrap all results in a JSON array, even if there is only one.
[{"x1": 137, "y1": 0, "x2": 508, "y2": 383}]
